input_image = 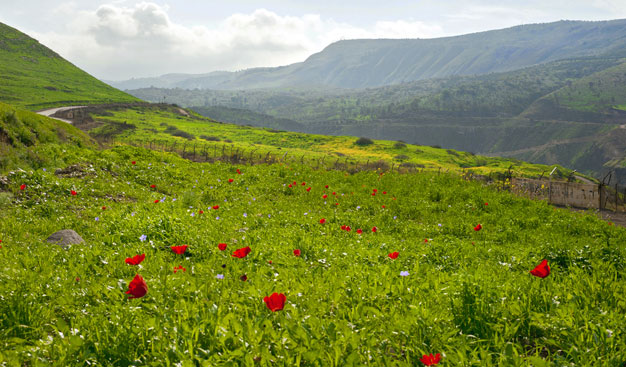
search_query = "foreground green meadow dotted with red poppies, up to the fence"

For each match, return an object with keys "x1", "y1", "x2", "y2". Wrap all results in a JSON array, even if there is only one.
[{"x1": 0, "y1": 145, "x2": 626, "y2": 366}]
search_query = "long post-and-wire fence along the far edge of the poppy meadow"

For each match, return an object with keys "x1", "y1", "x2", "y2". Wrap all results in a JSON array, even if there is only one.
[{"x1": 100, "y1": 134, "x2": 626, "y2": 211}]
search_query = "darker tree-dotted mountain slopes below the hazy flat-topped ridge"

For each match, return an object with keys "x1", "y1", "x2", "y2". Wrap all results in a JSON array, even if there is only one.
[{"x1": 131, "y1": 56, "x2": 626, "y2": 181}]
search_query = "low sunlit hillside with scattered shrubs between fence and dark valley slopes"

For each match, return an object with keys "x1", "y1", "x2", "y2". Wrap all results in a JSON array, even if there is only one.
[{"x1": 67, "y1": 104, "x2": 571, "y2": 180}]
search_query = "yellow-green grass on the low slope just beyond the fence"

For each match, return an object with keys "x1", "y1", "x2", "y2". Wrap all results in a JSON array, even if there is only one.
[{"x1": 90, "y1": 105, "x2": 569, "y2": 180}]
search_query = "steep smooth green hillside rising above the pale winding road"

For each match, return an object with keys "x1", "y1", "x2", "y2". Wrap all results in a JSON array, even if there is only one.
[{"x1": 0, "y1": 23, "x2": 137, "y2": 111}]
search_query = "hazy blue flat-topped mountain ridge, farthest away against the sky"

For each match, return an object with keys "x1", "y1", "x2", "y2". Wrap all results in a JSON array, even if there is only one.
[{"x1": 111, "y1": 19, "x2": 626, "y2": 90}]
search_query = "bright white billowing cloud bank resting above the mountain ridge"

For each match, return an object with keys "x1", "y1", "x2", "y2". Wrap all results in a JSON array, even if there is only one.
[{"x1": 32, "y1": 2, "x2": 442, "y2": 80}]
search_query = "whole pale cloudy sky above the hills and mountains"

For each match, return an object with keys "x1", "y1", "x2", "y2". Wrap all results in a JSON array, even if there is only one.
[{"x1": 0, "y1": 0, "x2": 626, "y2": 80}]
